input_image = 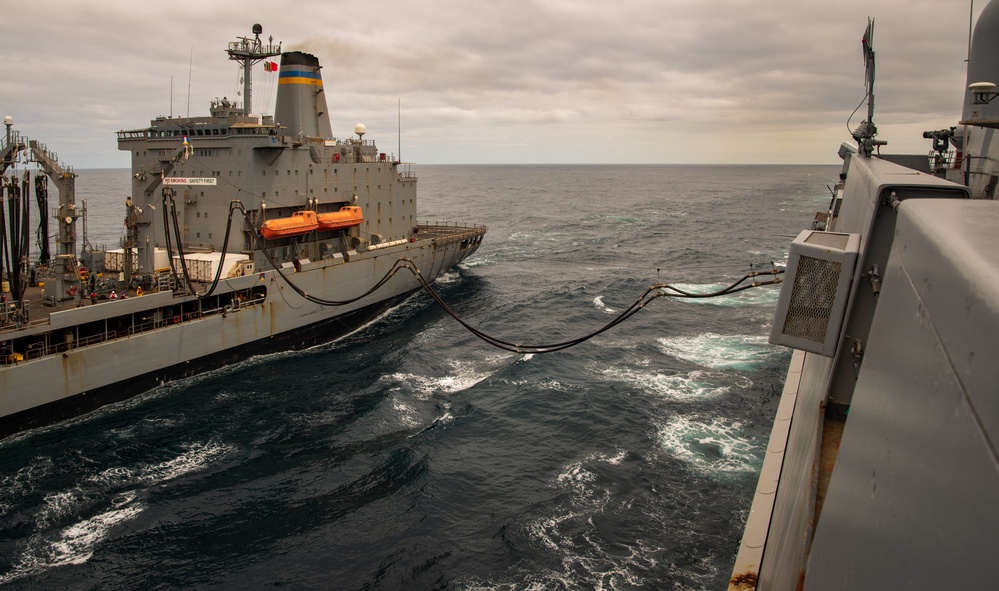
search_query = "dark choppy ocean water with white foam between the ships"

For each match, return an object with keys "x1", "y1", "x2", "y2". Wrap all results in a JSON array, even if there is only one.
[{"x1": 0, "y1": 165, "x2": 837, "y2": 590}]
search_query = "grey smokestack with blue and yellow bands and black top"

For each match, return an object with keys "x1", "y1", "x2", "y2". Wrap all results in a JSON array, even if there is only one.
[{"x1": 274, "y1": 51, "x2": 333, "y2": 139}]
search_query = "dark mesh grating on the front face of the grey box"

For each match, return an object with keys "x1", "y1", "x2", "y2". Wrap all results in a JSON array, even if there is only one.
[{"x1": 781, "y1": 256, "x2": 842, "y2": 344}]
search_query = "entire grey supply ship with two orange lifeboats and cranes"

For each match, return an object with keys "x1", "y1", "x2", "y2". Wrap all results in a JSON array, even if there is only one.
[{"x1": 0, "y1": 25, "x2": 486, "y2": 436}]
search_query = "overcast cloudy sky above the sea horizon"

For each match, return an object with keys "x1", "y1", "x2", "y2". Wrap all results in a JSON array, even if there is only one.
[{"x1": 0, "y1": 0, "x2": 986, "y2": 168}]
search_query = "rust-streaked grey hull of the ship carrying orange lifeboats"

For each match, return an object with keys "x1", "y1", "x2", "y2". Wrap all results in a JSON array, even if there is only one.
[{"x1": 0, "y1": 229, "x2": 484, "y2": 437}]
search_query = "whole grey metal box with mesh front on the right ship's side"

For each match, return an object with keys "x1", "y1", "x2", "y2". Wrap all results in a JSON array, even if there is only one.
[{"x1": 770, "y1": 230, "x2": 860, "y2": 357}]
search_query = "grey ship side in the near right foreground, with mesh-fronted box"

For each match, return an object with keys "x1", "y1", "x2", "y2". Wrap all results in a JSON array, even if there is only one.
[{"x1": 729, "y1": 0, "x2": 999, "y2": 591}]
